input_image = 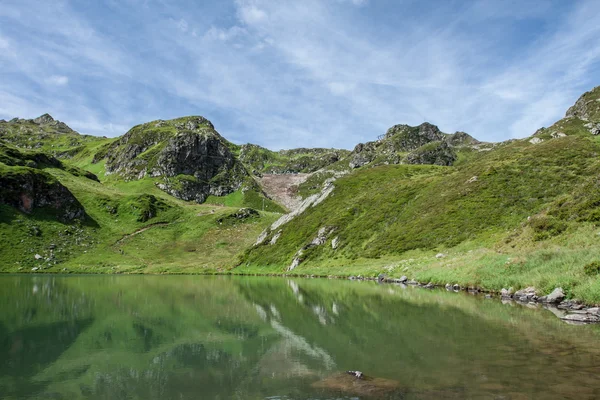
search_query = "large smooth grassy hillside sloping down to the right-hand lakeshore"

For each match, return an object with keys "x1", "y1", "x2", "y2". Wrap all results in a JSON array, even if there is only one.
[{"x1": 239, "y1": 89, "x2": 600, "y2": 302}]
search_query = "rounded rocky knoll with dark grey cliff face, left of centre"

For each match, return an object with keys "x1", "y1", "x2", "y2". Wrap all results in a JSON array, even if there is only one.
[{"x1": 106, "y1": 117, "x2": 248, "y2": 203}]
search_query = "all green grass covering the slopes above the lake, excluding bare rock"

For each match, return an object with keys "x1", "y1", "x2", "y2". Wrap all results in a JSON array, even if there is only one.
[{"x1": 0, "y1": 90, "x2": 600, "y2": 303}]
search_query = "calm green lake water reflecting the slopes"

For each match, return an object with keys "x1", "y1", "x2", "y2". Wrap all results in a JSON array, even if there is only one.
[{"x1": 0, "y1": 275, "x2": 600, "y2": 400}]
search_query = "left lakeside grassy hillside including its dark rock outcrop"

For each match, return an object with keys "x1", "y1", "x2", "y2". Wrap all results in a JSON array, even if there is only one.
[{"x1": 0, "y1": 137, "x2": 281, "y2": 273}]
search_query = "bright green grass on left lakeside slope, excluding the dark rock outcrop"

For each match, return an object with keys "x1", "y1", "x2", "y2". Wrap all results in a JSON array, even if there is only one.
[{"x1": 0, "y1": 161, "x2": 278, "y2": 273}]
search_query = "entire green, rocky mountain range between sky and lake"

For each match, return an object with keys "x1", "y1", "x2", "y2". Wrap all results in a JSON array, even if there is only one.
[{"x1": 0, "y1": 88, "x2": 600, "y2": 301}]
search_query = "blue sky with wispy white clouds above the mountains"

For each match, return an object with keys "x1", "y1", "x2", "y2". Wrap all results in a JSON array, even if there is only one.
[{"x1": 0, "y1": 0, "x2": 600, "y2": 149}]
